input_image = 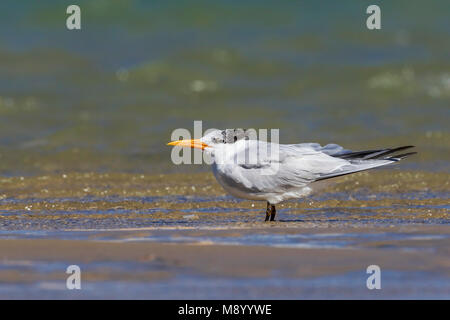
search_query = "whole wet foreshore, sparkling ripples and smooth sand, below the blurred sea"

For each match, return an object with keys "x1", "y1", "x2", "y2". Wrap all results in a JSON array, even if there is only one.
[{"x1": 0, "y1": 170, "x2": 450, "y2": 299}]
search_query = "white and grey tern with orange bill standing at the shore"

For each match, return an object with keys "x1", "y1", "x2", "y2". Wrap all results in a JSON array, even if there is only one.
[{"x1": 168, "y1": 129, "x2": 416, "y2": 221}]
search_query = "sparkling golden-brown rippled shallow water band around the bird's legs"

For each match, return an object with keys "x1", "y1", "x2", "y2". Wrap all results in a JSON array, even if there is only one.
[{"x1": 0, "y1": 170, "x2": 450, "y2": 230}]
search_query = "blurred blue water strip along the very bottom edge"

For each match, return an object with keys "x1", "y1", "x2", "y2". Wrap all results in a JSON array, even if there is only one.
[{"x1": 0, "y1": 266, "x2": 449, "y2": 300}]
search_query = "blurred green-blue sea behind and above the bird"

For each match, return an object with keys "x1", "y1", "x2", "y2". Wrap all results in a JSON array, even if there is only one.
[{"x1": 0, "y1": 0, "x2": 450, "y2": 176}]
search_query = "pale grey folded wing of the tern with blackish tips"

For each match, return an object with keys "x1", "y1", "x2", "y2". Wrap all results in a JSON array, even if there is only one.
[{"x1": 227, "y1": 141, "x2": 412, "y2": 192}]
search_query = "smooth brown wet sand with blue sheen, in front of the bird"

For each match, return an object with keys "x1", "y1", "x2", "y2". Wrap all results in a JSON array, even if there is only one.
[{"x1": 0, "y1": 227, "x2": 450, "y2": 299}]
